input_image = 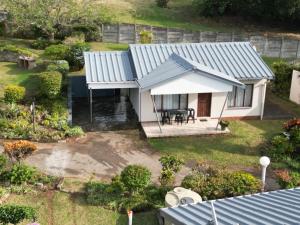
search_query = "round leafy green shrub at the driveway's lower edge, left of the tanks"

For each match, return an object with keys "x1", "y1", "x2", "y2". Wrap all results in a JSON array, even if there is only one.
[{"x1": 121, "y1": 165, "x2": 151, "y2": 193}]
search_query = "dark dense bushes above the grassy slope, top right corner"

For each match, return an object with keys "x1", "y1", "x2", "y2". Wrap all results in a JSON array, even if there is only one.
[{"x1": 194, "y1": 0, "x2": 300, "y2": 23}]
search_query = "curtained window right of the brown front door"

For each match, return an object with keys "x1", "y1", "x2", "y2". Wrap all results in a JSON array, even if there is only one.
[{"x1": 228, "y1": 84, "x2": 253, "y2": 108}]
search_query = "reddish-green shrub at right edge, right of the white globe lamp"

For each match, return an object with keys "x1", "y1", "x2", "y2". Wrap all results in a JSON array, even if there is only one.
[{"x1": 275, "y1": 169, "x2": 300, "y2": 188}]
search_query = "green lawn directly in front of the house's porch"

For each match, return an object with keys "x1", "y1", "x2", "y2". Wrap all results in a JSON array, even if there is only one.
[{"x1": 149, "y1": 120, "x2": 284, "y2": 168}]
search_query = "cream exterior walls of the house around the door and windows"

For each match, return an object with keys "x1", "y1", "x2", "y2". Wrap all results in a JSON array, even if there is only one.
[{"x1": 129, "y1": 80, "x2": 266, "y2": 122}]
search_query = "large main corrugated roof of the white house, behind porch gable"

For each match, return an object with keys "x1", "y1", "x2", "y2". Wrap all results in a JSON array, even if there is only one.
[{"x1": 129, "y1": 42, "x2": 274, "y2": 80}]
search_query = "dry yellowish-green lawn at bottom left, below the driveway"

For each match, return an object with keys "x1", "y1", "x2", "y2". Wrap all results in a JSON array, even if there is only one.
[{"x1": 7, "y1": 192, "x2": 158, "y2": 225}]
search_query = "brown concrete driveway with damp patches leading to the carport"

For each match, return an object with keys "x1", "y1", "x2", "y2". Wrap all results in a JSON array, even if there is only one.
[{"x1": 0, "y1": 130, "x2": 189, "y2": 184}]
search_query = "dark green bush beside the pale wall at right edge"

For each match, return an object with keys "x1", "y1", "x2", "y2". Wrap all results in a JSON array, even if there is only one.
[{"x1": 272, "y1": 61, "x2": 300, "y2": 97}]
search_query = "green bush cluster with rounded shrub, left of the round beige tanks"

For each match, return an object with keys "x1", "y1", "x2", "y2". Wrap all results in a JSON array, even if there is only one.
[{"x1": 86, "y1": 165, "x2": 169, "y2": 212}]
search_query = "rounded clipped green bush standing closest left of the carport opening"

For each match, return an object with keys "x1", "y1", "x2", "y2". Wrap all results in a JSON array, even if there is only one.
[{"x1": 40, "y1": 71, "x2": 62, "y2": 99}]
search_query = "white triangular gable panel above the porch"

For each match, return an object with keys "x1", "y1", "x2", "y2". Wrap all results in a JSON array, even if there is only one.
[{"x1": 151, "y1": 73, "x2": 232, "y2": 95}]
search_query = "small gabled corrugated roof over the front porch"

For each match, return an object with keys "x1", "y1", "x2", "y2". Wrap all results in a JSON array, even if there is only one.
[{"x1": 138, "y1": 53, "x2": 244, "y2": 90}]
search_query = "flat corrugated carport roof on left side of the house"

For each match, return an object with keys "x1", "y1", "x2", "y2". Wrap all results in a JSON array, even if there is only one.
[{"x1": 84, "y1": 51, "x2": 134, "y2": 83}]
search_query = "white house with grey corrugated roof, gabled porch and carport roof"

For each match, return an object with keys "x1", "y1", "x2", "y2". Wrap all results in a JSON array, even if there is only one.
[{"x1": 84, "y1": 42, "x2": 274, "y2": 136}]
